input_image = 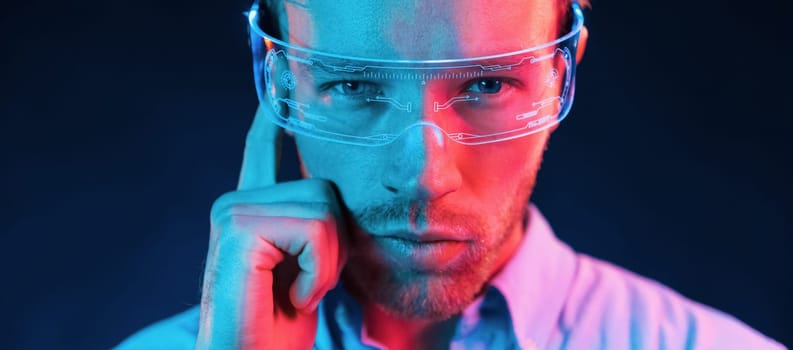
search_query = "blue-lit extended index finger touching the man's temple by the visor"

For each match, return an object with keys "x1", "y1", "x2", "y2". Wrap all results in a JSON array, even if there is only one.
[{"x1": 237, "y1": 104, "x2": 284, "y2": 190}]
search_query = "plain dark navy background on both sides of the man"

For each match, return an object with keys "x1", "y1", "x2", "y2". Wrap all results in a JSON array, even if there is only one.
[{"x1": 0, "y1": 0, "x2": 793, "y2": 349}]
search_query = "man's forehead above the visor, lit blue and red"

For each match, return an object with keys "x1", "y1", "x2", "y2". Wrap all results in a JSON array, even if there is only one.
[{"x1": 284, "y1": 0, "x2": 559, "y2": 59}]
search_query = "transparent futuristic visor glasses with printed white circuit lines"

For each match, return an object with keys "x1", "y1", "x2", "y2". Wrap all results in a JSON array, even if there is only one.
[{"x1": 251, "y1": 3, "x2": 581, "y2": 146}]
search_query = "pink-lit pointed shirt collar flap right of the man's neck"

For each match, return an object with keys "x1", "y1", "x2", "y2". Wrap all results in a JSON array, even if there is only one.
[{"x1": 490, "y1": 204, "x2": 576, "y2": 349}]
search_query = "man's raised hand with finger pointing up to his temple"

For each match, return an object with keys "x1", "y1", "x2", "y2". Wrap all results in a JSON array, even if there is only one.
[{"x1": 196, "y1": 107, "x2": 346, "y2": 349}]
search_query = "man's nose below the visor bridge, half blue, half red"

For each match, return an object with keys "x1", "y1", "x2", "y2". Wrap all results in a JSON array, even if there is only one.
[{"x1": 382, "y1": 121, "x2": 462, "y2": 201}]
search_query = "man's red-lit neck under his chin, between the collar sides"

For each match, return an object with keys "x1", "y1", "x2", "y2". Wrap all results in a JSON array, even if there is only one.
[{"x1": 363, "y1": 304, "x2": 460, "y2": 350}]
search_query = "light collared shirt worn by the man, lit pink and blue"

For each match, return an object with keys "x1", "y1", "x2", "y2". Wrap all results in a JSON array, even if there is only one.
[{"x1": 117, "y1": 205, "x2": 784, "y2": 350}]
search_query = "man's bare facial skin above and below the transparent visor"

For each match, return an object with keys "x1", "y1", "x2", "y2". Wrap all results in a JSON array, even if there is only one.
[{"x1": 284, "y1": 0, "x2": 559, "y2": 319}]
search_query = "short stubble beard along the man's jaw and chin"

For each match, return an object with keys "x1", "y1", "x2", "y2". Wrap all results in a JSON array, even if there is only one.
[{"x1": 342, "y1": 176, "x2": 535, "y2": 321}]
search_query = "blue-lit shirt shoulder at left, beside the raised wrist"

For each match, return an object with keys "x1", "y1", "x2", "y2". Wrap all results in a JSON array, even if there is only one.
[{"x1": 114, "y1": 306, "x2": 199, "y2": 350}]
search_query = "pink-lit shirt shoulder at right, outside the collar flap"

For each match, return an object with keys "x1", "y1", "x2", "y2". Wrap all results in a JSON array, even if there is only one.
[{"x1": 560, "y1": 255, "x2": 784, "y2": 349}]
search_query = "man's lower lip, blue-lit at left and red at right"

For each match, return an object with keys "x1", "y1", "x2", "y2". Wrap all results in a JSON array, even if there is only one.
[{"x1": 375, "y1": 236, "x2": 465, "y2": 270}]
